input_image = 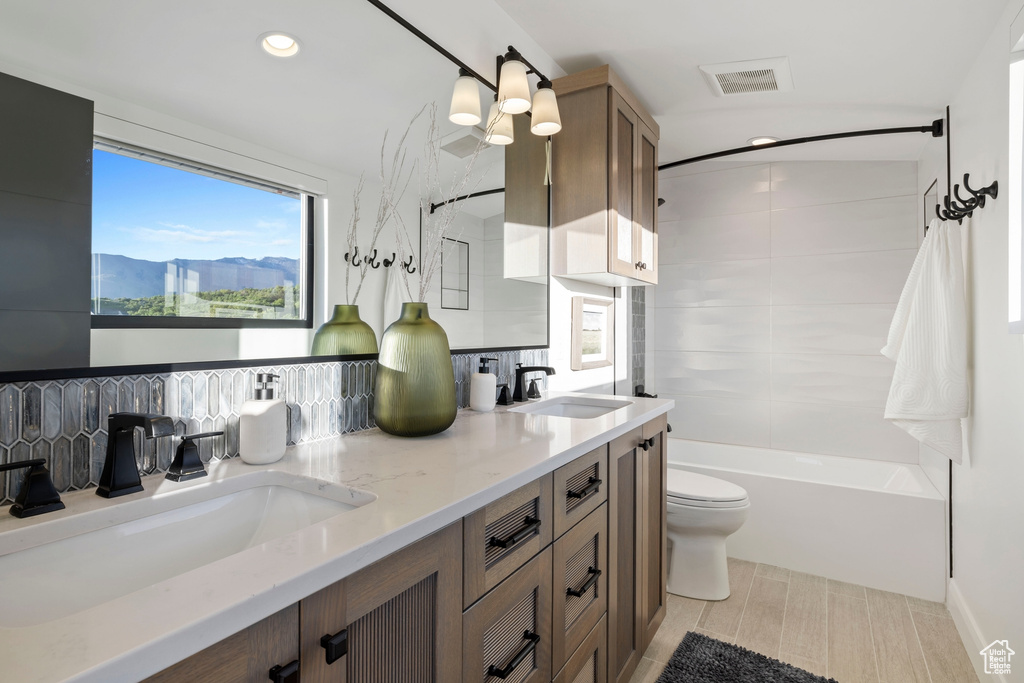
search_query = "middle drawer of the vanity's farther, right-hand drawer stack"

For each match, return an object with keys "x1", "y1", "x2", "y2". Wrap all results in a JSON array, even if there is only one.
[{"x1": 551, "y1": 505, "x2": 608, "y2": 671}]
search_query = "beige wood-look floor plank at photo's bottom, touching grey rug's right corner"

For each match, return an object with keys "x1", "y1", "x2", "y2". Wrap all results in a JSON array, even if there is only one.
[{"x1": 828, "y1": 593, "x2": 879, "y2": 683}]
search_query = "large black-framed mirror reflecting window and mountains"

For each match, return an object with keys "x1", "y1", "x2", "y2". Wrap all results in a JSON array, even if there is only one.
[{"x1": 0, "y1": 0, "x2": 548, "y2": 373}]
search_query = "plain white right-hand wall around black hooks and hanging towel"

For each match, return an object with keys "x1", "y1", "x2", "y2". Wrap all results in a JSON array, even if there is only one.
[{"x1": 919, "y1": 0, "x2": 1024, "y2": 681}]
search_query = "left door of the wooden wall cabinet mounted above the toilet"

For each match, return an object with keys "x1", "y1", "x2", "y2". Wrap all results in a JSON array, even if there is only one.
[{"x1": 608, "y1": 88, "x2": 639, "y2": 278}]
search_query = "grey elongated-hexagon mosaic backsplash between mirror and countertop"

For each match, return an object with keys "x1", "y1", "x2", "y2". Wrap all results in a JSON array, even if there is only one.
[{"x1": 0, "y1": 349, "x2": 548, "y2": 505}]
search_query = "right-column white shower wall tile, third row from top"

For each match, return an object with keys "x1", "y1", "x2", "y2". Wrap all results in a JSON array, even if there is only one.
[{"x1": 771, "y1": 249, "x2": 918, "y2": 305}]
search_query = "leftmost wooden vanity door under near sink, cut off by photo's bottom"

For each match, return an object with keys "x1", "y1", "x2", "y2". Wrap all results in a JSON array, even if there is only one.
[{"x1": 144, "y1": 603, "x2": 306, "y2": 683}]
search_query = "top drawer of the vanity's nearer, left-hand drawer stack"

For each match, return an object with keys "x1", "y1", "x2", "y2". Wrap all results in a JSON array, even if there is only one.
[{"x1": 463, "y1": 474, "x2": 552, "y2": 607}]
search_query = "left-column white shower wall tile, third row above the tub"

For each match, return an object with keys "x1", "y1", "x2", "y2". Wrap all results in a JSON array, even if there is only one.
[{"x1": 654, "y1": 306, "x2": 771, "y2": 352}]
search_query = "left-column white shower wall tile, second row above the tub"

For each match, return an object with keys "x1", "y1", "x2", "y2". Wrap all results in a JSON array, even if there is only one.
[{"x1": 647, "y1": 351, "x2": 771, "y2": 400}]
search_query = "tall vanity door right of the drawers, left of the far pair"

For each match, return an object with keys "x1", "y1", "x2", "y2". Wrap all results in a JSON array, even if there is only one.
[{"x1": 608, "y1": 427, "x2": 643, "y2": 683}]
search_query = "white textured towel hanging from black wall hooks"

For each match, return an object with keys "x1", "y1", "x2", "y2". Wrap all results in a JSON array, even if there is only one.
[{"x1": 882, "y1": 218, "x2": 969, "y2": 463}]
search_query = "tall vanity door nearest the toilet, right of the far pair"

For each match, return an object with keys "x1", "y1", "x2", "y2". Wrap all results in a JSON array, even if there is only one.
[{"x1": 639, "y1": 415, "x2": 669, "y2": 650}]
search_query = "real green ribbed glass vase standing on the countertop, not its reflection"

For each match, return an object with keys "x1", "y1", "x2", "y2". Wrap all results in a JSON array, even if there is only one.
[{"x1": 374, "y1": 303, "x2": 458, "y2": 436}]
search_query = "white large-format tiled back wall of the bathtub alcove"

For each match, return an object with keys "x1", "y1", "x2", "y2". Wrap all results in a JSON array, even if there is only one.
[{"x1": 648, "y1": 162, "x2": 922, "y2": 463}]
